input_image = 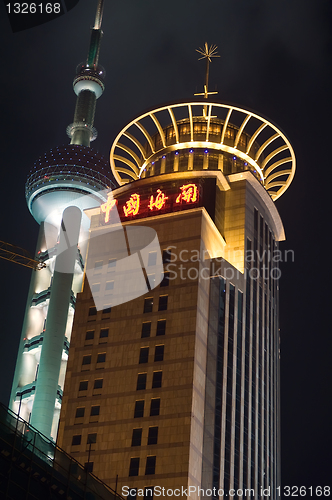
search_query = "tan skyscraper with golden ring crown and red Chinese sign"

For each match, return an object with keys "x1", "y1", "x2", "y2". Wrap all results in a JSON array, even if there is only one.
[{"x1": 59, "y1": 55, "x2": 295, "y2": 499}]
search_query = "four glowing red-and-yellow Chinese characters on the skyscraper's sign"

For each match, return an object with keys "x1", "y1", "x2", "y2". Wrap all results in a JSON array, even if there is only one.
[{"x1": 101, "y1": 184, "x2": 198, "y2": 223}]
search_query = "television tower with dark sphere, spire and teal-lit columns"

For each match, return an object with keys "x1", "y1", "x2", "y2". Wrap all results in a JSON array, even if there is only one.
[{"x1": 9, "y1": 0, "x2": 114, "y2": 440}]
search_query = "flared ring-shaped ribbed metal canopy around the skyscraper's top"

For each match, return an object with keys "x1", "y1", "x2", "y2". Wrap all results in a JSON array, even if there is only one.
[{"x1": 110, "y1": 101, "x2": 296, "y2": 200}]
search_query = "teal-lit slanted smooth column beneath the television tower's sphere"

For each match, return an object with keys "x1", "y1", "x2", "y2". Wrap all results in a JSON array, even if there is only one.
[{"x1": 31, "y1": 207, "x2": 82, "y2": 437}]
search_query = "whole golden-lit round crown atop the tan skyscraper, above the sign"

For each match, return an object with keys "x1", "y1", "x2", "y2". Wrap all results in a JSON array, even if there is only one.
[{"x1": 110, "y1": 101, "x2": 296, "y2": 200}]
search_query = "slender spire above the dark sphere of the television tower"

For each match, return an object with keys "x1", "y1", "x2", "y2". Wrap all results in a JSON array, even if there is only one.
[{"x1": 67, "y1": 0, "x2": 105, "y2": 146}]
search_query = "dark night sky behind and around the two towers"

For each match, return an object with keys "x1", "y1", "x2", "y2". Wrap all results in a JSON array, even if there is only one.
[{"x1": 0, "y1": 0, "x2": 332, "y2": 487}]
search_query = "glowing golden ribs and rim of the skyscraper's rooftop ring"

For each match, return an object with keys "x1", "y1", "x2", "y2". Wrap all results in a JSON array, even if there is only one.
[{"x1": 110, "y1": 101, "x2": 296, "y2": 200}]
